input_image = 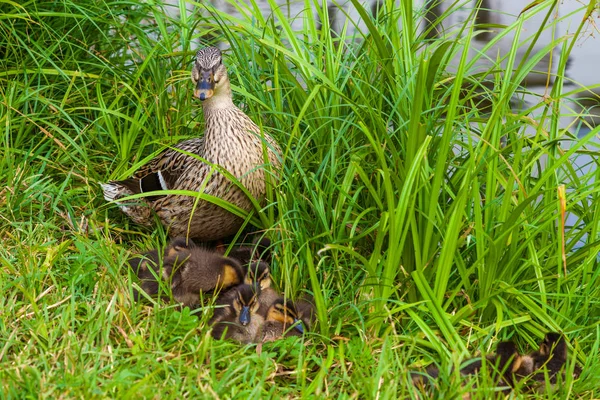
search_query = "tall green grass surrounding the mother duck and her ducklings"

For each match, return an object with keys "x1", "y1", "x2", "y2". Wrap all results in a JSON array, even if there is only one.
[{"x1": 0, "y1": 0, "x2": 600, "y2": 398}]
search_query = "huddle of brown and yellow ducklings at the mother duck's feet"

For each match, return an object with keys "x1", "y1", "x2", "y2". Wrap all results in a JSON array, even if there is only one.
[{"x1": 129, "y1": 238, "x2": 314, "y2": 343}]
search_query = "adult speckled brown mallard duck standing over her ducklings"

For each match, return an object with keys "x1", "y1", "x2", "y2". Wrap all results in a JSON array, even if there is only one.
[{"x1": 102, "y1": 47, "x2": 281, "y2": 241}]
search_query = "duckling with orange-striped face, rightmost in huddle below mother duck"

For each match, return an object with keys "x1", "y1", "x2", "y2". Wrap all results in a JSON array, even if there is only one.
[{"x1": 260, "y1": 297, "x2": 304, "y2": 342}]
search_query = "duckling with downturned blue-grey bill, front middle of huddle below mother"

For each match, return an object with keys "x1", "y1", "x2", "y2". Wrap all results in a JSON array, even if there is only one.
[{"x1": 210, "y1": 284, "x2": 264, "y2": 344}]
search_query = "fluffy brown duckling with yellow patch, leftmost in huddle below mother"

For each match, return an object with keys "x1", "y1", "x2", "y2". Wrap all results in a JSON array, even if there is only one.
[{"x1": 130, "y1": 238, "x2": 244, "y2": 307}]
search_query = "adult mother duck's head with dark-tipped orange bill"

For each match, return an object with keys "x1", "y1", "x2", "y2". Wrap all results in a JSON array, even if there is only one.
[{"x1": 192, "y1": 47, "x2": 227, "y2": 101}]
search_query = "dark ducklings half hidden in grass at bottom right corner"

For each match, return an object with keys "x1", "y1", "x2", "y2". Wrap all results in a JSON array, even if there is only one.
[{"x1": 411, "y1": 332, "x2": 581, "y2": 398}]
